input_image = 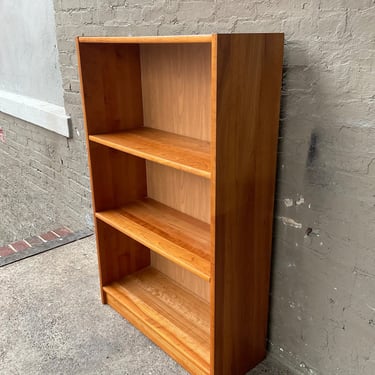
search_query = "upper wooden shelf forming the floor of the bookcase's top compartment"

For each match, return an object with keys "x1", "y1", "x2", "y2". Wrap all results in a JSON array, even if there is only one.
[{"x1": 89, "y1": 127, "x2": 211, "y2": 178}]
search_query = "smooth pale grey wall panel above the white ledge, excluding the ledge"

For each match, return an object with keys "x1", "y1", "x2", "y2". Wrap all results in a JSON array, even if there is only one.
[{"x1": 0, "y1": 0, "x2": 64, "y2": 105}]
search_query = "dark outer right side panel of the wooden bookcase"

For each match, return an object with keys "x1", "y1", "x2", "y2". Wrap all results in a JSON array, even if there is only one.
[{"x1": 213, "y1": 34, "x2": 283, "y2": 375}]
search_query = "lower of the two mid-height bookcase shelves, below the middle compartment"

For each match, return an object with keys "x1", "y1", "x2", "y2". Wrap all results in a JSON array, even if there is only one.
[{"x1": 95, "y1": 198, "x2": 211, "y2": 281}]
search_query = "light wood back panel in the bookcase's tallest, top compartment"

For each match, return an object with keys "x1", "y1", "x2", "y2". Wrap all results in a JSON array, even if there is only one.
[{"x1": 140, "y1": 43, "x2": 211, "y2": 141}]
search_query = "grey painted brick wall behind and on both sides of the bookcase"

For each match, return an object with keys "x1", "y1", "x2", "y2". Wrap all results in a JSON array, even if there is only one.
[{"x1": 0, "y1": 0, "x2": 375, "y2": 375}]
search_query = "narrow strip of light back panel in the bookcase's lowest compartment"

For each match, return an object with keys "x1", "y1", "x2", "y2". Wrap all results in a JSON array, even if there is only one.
[{"x1": 151, "y1": 251, "x2": 210, "y2": 302}]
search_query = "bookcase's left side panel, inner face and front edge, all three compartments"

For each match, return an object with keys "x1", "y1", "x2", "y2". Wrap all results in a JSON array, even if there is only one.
[{"x1": 76, "y1": 37, "x2": 150, "y2": 303}]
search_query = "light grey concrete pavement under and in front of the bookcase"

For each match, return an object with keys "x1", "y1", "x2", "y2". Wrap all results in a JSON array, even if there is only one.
[{"x1": 0, "y1": 236, "x2": 291, "y2": 375}]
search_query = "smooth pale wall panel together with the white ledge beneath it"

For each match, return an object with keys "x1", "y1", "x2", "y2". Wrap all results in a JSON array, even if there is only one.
[{"x1": 0, "y1": 0, "x2": 69, "y2": 136}]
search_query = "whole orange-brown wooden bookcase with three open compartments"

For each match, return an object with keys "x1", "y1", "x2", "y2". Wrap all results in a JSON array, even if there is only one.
[{"x1": 77, "y1": 34, "x2": 283, "y2": 375}]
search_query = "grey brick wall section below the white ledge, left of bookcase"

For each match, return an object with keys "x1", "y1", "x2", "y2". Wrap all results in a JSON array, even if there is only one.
[{"x1": 0, "y1": 113, "x2": 91, "y2": 245}]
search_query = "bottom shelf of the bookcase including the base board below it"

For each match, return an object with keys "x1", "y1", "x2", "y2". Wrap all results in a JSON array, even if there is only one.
[{"x1": 103, "y1": 267, "x2": 210, "y2": 374}]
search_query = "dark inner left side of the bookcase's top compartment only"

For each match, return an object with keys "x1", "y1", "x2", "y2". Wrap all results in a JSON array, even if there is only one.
[{"x1": 80, "y1": 43, "x2": 143, "y2": 134}]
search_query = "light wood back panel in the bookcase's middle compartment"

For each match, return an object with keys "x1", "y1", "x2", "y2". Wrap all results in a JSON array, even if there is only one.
[{"x1": 146, "y1": 161, "x2": 210, "y2": 223}]
